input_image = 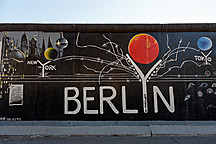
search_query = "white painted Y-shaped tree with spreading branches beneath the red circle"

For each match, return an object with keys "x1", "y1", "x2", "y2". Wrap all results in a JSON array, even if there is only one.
[{"x1": 76, "y1": 33, "x2": 208, "y2": 113}]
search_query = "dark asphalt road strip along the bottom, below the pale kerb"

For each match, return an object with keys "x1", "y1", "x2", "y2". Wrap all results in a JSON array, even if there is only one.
[{"x1": 0, "y1": 136, "x2": 216, "y2": 144}]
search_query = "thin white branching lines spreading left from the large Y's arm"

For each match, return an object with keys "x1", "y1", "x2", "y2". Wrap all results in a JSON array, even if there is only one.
[{"x1": 54, "y1": 33, "x2": 139, "y2": 84}]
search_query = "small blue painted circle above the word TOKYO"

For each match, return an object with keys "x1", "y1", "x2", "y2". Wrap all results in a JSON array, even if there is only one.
[{"x1": 197, "y1": 37, "x2": 212, "y2": 51}]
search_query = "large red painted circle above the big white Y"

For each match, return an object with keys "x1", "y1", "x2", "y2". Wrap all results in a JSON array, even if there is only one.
[{"x1": 128, "y1": 34, "x2": 159, "y2": 64}]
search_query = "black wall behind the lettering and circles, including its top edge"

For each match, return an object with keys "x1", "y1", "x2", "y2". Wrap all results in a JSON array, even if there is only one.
[{"x1": 0, "y1": 24, "x2": 216, "y2": 121}]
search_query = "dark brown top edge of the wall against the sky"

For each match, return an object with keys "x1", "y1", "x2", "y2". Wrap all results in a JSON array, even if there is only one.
[{"x1": 0, "y1": 23, "x2": 216, "y2": 33}]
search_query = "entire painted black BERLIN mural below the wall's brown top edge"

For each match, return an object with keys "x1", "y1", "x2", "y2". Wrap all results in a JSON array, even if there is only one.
[{"x1": 0, "y1": 31, "x2": 216, "y2": 121}]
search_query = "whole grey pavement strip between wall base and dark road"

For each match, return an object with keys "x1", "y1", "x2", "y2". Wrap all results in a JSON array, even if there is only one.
[{"x1": 0, "y1": 121, "x2": 216, "y2": 137}]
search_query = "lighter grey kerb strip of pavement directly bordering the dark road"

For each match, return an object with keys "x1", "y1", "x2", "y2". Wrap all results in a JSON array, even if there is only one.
[{"x1": 0, "y1": 125, "x2": 216, "y2": 137}]
